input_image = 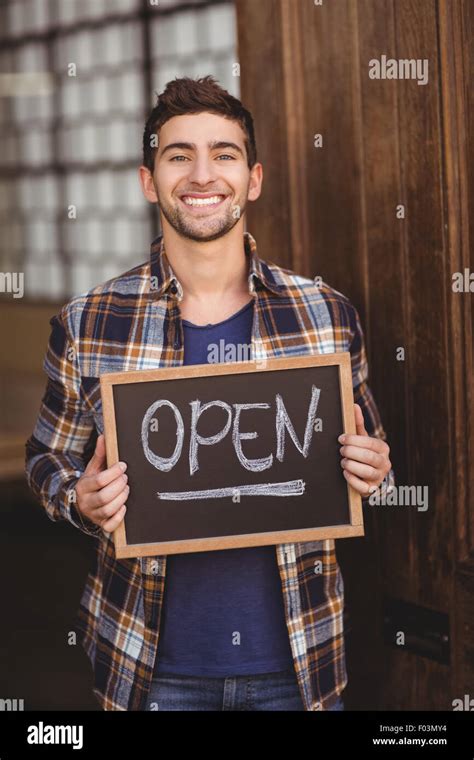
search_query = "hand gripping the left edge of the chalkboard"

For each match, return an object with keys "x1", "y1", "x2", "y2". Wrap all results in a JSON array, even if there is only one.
[{"x1": 75, "y1": 435, "x2": 130, "y2": 533}]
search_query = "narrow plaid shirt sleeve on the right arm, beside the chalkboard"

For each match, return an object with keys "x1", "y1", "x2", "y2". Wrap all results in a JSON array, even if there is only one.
[{"x1": 350, "y1": 307, "x2": 395, "y2": 501}]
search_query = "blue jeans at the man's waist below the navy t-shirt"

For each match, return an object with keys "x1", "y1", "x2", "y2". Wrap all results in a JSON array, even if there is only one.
[{"x1": 147, "y1": 669, "x2": 344, "y2": 711}]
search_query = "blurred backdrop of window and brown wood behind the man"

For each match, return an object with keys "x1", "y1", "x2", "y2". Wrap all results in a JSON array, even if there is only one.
[{"x1": 0, "y1": 0, "x2": 474, "y2": 710}]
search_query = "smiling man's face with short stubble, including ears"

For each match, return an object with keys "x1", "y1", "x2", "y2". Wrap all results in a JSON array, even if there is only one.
[{"x1": 147, "y1": 113, "x2": 261, "y2": 242}]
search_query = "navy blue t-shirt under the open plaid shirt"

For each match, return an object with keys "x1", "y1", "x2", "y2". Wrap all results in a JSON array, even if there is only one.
[{"x1": 155, "y1": 299, "x2": 293, "y2": 677}]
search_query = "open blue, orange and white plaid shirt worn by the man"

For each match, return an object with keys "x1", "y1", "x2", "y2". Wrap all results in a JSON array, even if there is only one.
[{"x1": 26, "y1": 232, "x2": 394, "y2": 710}]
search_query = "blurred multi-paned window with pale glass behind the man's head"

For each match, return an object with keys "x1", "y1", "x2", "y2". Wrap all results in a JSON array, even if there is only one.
[{"x1": 0, "y1": 0, "x2": 239, "y2": 300}]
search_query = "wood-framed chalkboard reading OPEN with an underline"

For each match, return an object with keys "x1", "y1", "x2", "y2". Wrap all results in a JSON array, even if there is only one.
[{"x1": 101, "y1": 352, "x2": 364, "y2": 558}]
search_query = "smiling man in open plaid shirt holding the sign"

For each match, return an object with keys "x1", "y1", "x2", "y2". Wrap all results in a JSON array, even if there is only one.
[{"x1": 27, "y1": 77, "x2": 393, "y2": 710}]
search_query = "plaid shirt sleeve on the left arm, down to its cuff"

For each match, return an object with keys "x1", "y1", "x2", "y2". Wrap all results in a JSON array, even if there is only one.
[{"x1": 25, "y1": 307, "x2": 103, "y2": 537}]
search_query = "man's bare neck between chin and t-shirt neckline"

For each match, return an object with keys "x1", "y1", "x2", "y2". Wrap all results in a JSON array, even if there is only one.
[{"x1": 163, "y1": 219, "x2": 248, "y2": 302}]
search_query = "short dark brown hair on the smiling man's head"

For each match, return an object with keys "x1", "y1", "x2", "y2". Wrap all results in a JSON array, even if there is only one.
[{"x1": 143, "y1": 75, "x2": 257, "y2": 172}]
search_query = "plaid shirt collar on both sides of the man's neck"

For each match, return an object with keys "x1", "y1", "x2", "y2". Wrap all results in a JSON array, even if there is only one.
[{"x1": 149, "y1": 232, "x2": 286, "y2": 301}]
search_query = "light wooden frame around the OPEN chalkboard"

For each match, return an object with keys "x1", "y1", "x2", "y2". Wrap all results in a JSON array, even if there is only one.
[{"x1": 100, "y1": 352, "x2": 364, "y2": 559}]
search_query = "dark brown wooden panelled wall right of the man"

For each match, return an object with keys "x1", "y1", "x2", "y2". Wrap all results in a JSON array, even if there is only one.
[{"x1": 236, "y1": 0, "x2": 474, "y2": 709}]
